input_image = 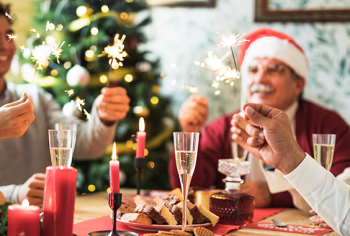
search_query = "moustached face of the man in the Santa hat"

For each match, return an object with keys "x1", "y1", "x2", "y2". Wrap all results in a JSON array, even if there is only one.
[{"x1": 246, "y1": 58, "x2": 305, "y2": 110}]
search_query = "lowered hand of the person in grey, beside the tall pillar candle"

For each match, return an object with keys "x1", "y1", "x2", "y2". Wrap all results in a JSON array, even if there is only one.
[{"x1": 18, "y1": 173, "x2": 45, "y2": 206}]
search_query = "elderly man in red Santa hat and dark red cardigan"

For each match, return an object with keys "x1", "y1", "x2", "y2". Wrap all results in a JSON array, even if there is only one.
[{"x1": 169, "y1": 29, "x2": 350, "y2": 210}]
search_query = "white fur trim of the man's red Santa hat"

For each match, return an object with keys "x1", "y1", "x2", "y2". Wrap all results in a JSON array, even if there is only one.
[{"x1": 241, "y1": 36, "x2": 309, "y2": 79}]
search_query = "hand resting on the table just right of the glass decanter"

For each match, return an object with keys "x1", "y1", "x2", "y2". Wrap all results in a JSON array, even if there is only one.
[{"x1": 241, "y1": 181, "x2": 271, "y2": 208}]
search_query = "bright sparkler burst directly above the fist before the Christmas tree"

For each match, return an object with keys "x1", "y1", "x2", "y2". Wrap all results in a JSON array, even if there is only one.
[{"x1": 98, "y1": 34, "x2": 128, "y2": 69}]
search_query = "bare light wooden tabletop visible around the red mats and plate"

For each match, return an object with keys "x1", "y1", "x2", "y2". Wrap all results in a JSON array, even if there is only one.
[{"x1": 74, "y1": 189, "x2": 339, "y2": 236}]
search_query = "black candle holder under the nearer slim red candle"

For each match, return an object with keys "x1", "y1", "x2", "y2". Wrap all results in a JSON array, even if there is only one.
[{"x1": 88, "y1": 193, "x2": 139, "y2": 236}]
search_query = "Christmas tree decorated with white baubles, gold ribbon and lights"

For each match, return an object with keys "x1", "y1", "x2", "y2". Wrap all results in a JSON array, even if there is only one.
[{"x1": 21, "y1": 0, "x2": 175, "y2": 193}]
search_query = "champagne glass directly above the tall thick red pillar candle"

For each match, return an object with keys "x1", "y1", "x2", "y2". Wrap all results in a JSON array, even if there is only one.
[{"x1": 49, "y1": 129, "x2": 76, "y2": 167}]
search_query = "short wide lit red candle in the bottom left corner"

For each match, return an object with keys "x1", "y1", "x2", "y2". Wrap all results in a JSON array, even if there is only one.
[{"x1": 7, "y1": 199, "x2": 40, "y2": 236}]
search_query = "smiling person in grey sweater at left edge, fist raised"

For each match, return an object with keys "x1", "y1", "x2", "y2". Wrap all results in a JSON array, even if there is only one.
[{"x1": 0, "y1": 3, "x2": 130, "y2": 205}]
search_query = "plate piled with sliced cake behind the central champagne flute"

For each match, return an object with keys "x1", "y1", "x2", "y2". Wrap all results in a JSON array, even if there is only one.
[{"x1": 115, "y1": 190, "x2": 219, "y2": 231}]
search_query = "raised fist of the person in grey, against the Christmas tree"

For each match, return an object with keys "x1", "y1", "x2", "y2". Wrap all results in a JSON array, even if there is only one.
[{"x1": 96, "y1": 87, "x2": 130, "y2": 125}]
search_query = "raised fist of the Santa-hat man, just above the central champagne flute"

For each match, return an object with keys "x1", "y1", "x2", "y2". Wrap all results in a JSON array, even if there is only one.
[{"x1": 179, "y1": 94, "x2": 209, "y2": 132}]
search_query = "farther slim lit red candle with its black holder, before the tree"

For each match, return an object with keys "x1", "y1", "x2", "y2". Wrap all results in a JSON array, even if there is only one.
[{"x1": 134, "y1": 117, "x2": 146, "y2": 194}]
